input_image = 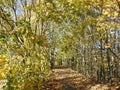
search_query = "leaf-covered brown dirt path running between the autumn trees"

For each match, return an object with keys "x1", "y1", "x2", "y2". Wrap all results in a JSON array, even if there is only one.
[{"x1": 45, "y1": 68, "x2": 120, "y2": 90}]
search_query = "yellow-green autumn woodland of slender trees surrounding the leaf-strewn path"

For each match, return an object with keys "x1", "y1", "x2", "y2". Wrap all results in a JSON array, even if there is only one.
[{"x1": 0, "y1": 0, "x2": 120, "y2": 90}]
